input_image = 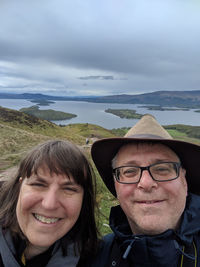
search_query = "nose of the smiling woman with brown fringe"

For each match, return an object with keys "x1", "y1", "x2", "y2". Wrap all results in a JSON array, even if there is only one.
[{"x1": 42, "y1": 189, "x2": 59, "y2": 210}]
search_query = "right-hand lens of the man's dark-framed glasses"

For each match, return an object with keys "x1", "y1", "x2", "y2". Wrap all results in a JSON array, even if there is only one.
[{"x1": 149, "y1": 162, "x2": 178, "y2": 181}]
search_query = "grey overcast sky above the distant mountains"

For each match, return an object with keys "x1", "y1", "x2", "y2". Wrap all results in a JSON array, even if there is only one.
[{"x1": 0, "y1": 0, "x2": 200, "y2": 96}]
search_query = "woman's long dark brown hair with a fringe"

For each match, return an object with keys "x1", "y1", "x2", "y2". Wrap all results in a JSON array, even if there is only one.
[{"x1": 0, "y1": 140, "x2": 98, "y2": 258}]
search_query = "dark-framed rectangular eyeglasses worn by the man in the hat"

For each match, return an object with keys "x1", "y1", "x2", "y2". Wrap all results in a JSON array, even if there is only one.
[{"x1": 113, "y1": 162, "x2": 181, "y2": 184}]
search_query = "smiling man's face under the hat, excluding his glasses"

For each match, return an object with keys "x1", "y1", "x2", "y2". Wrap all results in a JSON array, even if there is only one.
[{"x1": 115, "y1": 143, "x2": 187, "y2": 235}]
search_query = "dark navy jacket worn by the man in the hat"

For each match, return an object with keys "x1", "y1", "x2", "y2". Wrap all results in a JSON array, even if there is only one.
[{"x1": 89, "y1": 194, "x2": 200, "y2": 267}]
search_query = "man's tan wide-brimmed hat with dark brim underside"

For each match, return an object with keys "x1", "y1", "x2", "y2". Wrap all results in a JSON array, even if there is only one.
[{"x1": 91, "y1": 114, "x2": 200, "y2": 196}]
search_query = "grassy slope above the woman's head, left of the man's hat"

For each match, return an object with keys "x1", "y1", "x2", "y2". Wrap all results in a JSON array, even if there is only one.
[{"x1": 0, "y1": 107, "x2": 115, "y2": 170}]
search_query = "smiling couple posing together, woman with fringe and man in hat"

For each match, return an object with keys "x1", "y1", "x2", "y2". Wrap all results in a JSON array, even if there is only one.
[{"x1": 0, "y1": 114, "x2": 200, "y2": 267}]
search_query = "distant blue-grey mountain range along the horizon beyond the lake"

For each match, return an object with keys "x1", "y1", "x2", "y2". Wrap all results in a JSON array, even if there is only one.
[{"x1": 0, "y1": 90, "x2": 200, "y2": 108}]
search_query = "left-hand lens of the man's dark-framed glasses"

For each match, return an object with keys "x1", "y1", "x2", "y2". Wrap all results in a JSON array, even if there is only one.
[{"x1": 116, "y1": 167, "x2": 141, "y2": 184}]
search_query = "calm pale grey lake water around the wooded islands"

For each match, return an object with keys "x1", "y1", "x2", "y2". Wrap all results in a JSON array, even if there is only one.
[{"x1": 0, "y1": 99, "x2": 200, "y2": 129}]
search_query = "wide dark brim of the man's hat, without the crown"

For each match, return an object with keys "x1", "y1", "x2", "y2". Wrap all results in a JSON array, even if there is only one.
[{"x1": 91, "y1": 137, "x2": 200, "y2": 196}]
